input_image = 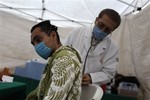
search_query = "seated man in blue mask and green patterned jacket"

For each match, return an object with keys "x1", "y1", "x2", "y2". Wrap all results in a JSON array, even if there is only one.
[{"x1": 26, "y1": 21, "x2": 82, "y2": 100}]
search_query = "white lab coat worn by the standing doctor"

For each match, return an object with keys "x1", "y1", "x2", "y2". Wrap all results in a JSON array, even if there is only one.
[{"x1": 65, "y1": 26, "x2": 118, "y2": 85}]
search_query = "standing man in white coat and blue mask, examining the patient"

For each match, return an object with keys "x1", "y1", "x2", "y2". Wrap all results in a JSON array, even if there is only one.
[{"x1": 65, "y1": 9, "x2": 121, "y2": 85}]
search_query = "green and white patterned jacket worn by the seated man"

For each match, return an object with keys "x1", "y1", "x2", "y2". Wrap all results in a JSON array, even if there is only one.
[{"x1": 27, "y1": 46, "x2": 82, "y2": 100}]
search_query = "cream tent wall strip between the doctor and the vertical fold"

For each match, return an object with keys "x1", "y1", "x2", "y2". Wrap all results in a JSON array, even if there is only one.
[{"x1": 111, "y1": 14, "x2": 135, "y2": 75}]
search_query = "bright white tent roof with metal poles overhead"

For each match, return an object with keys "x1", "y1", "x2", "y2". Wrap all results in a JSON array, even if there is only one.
[{"x1": 0, "y1": 0, "x2": 150, "y2": 27}]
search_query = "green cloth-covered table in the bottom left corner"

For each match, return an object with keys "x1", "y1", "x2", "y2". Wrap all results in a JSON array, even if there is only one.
[{"x1": 0, "y1": 82, "x2": 26, "y2": 100}]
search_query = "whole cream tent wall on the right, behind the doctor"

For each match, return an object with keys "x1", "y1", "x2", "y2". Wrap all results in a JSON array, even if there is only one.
[{"x1": 112, "y1": 5, "x2": 150, "y2": 100}]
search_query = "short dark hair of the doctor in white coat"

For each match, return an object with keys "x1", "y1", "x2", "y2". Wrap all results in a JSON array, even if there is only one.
[{"x1": 98, "y1": 9, "x2": 121, "y2": 29}]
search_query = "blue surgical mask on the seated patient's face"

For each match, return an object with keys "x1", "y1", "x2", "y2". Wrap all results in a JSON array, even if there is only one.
[{"x1": 34, "y1": 42, "x2": 52, "y2": 59}]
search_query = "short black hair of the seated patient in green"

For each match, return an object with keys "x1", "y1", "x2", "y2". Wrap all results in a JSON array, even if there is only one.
[{"x1": 30, "y1": 20, "x2": 60, "y2": 43}]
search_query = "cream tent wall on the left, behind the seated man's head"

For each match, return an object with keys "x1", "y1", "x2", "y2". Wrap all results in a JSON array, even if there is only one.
[{"x1": 0, "y1": 11, "x2": 72, "y2": 72}]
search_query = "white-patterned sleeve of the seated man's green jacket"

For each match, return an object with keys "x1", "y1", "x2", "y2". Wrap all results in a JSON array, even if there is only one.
[{"x1": 43, "y1": 51, "x2": 81, "y2": 100}]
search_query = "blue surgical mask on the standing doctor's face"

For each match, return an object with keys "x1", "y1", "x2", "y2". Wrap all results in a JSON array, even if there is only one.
[{"x1": 93, "y1": 25, "x2": 108, "y2": 41}]
